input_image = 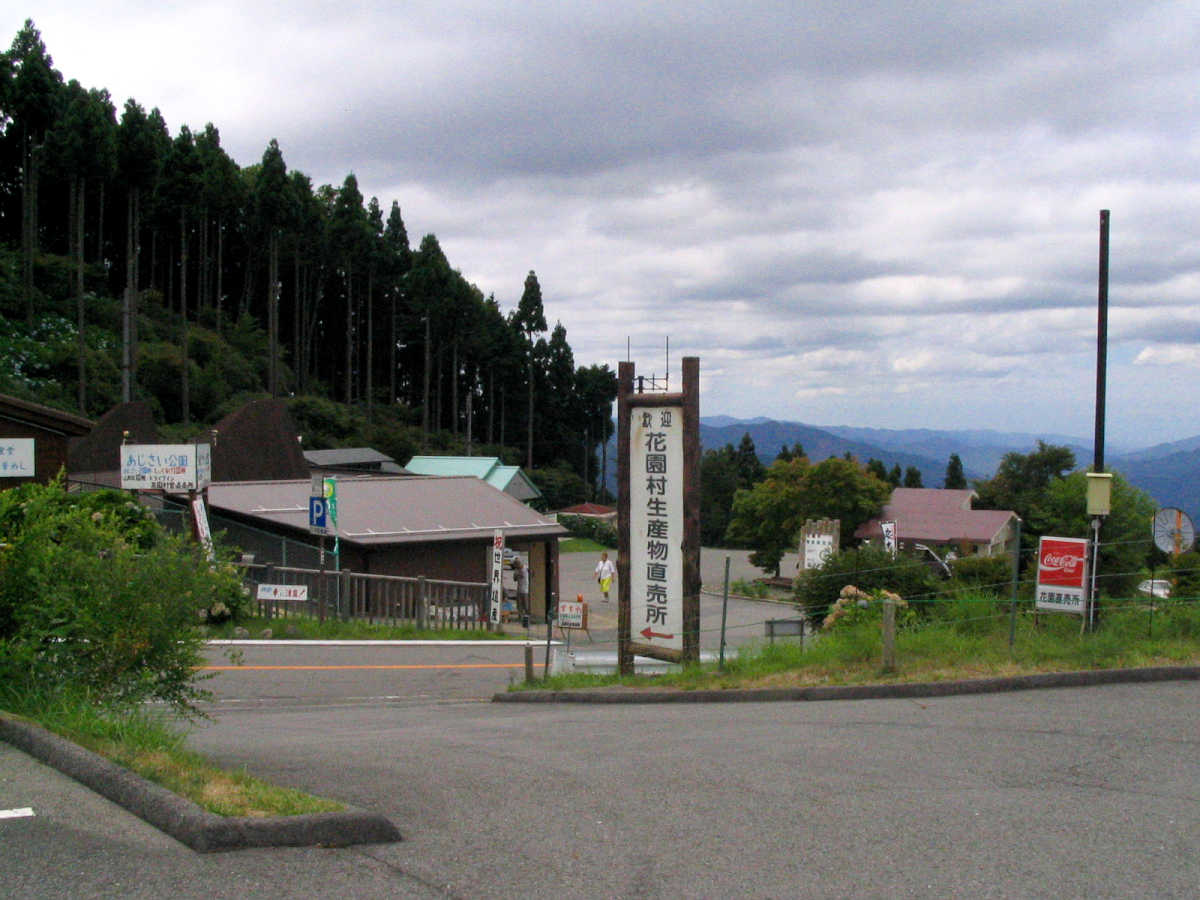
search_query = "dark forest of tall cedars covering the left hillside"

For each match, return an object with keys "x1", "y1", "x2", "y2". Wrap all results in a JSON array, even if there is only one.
[{"x1": 0, "y1": 22, "x2": 617, "y2": 503}]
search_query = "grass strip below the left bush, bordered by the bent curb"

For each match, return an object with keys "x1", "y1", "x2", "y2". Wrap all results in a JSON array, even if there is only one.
[{"x1": 0, "y1": 694, "x2": 344, "y2": 817}]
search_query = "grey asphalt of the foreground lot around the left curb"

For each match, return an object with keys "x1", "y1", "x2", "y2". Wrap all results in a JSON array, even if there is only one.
[{"x1": 0, "y1": 683, "x2": 1200, "y2": 898}]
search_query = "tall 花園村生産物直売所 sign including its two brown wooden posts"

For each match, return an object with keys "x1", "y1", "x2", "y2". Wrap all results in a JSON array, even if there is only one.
[{"x1": 617, "y1": 356, "x2": 700, "y2": 674}]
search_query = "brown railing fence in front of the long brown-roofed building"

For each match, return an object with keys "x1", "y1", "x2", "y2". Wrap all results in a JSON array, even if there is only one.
[{"x1": 245, "y1": 563, "x2": 488, "y2": 630}]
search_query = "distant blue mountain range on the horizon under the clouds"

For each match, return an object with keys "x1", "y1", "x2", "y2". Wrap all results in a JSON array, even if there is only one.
[{"x1": 610, "y1": 415, "x2": 1200, "y2": 518}]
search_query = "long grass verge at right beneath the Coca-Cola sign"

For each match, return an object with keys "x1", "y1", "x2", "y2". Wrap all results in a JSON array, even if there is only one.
[{"x1": 511, "y1": 604, "x2": 1200, "y2": 690}]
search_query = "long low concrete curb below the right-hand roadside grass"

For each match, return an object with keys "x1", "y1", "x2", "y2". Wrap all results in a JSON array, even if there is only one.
[{"x1": 492, "y1": 666, "x2": 1200, "y2": 703}]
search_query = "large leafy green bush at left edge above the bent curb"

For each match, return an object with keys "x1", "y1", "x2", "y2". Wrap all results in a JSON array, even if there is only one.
[{"x1": 0, "y1": 482, "x2": 244, "y2": 713}]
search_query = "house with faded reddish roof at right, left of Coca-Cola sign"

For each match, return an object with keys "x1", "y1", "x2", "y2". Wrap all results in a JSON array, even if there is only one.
[{"x1": 854, "y1": 487, "x2": 1016, "y2": 557}]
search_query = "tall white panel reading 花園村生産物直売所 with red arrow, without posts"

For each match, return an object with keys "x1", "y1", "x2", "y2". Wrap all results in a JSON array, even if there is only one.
[{"x1": 629, "y1": 406, "x2": 684, "y2": 650}]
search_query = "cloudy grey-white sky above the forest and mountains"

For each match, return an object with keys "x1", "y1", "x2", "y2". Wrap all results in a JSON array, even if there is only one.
[{"x1": 16, "y1": 0, "x2": 1200, "y2": 449}]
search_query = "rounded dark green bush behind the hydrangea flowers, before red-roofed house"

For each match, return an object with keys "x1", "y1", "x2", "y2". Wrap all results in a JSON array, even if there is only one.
[{"x1": 796, "y1": 546, "x2": 941, "y2": 623}]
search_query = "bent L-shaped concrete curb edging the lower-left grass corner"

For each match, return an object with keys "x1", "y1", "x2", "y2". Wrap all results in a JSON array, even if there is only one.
[{"x1": 0, "y1": 713, "x2": 401, "y2": 853}]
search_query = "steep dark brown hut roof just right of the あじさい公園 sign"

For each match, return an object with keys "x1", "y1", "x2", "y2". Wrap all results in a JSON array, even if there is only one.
[{"x1": 202, "y1": 400, "x2": 310, "y2": 482}]
